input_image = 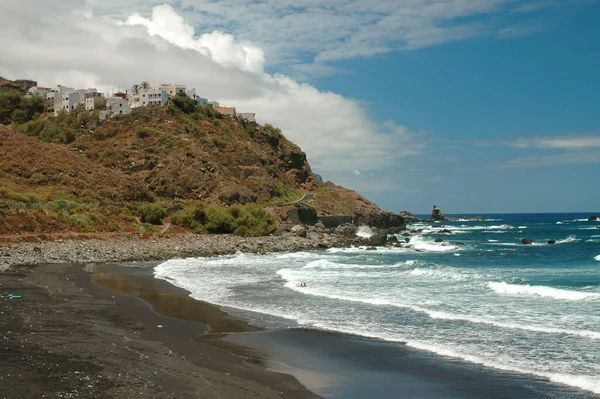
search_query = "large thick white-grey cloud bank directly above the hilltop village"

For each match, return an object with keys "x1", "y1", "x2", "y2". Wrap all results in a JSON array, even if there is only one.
[{"x1": 0, "y1": 0, "x2": 423, "y2": 192}]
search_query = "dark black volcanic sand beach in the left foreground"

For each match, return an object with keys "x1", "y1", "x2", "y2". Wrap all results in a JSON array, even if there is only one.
[{"x1": 0, "y1": 265, "x2": 318, "y2": 399}]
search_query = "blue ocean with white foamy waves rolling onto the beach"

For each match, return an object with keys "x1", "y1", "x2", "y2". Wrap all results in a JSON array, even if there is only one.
[{"x1": 154, "y1": 213, "x2": 600, "y2": 398}]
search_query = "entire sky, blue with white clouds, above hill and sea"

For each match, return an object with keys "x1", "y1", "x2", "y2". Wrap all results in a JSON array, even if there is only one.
[{"x1": 0, "y1": 0, "x2": 600, "y2": 214}]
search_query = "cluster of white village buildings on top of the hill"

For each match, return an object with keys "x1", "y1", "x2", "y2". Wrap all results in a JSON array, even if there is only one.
[{"x1": 18, "y1": 80, "x2": 256, "y2": 122}]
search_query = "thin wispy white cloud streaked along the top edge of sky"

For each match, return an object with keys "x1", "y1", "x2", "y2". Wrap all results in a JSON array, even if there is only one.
[{"x1": 44, "y1": 0, "x2": 594, "y2": 76}]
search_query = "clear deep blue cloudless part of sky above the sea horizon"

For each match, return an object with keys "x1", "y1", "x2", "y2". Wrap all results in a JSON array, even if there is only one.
[{"x1": 314, "y1": 3, "x2": 600, "y2": 213}]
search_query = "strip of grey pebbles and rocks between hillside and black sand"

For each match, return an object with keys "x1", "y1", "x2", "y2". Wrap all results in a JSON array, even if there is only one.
[{"x1": 0, "y1": 226, "x2": 387, "y2": 271}]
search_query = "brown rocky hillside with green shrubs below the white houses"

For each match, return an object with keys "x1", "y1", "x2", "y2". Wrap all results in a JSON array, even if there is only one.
[{"x1": 0, "y1": 79, "x2": 404, "y2": 239}]
